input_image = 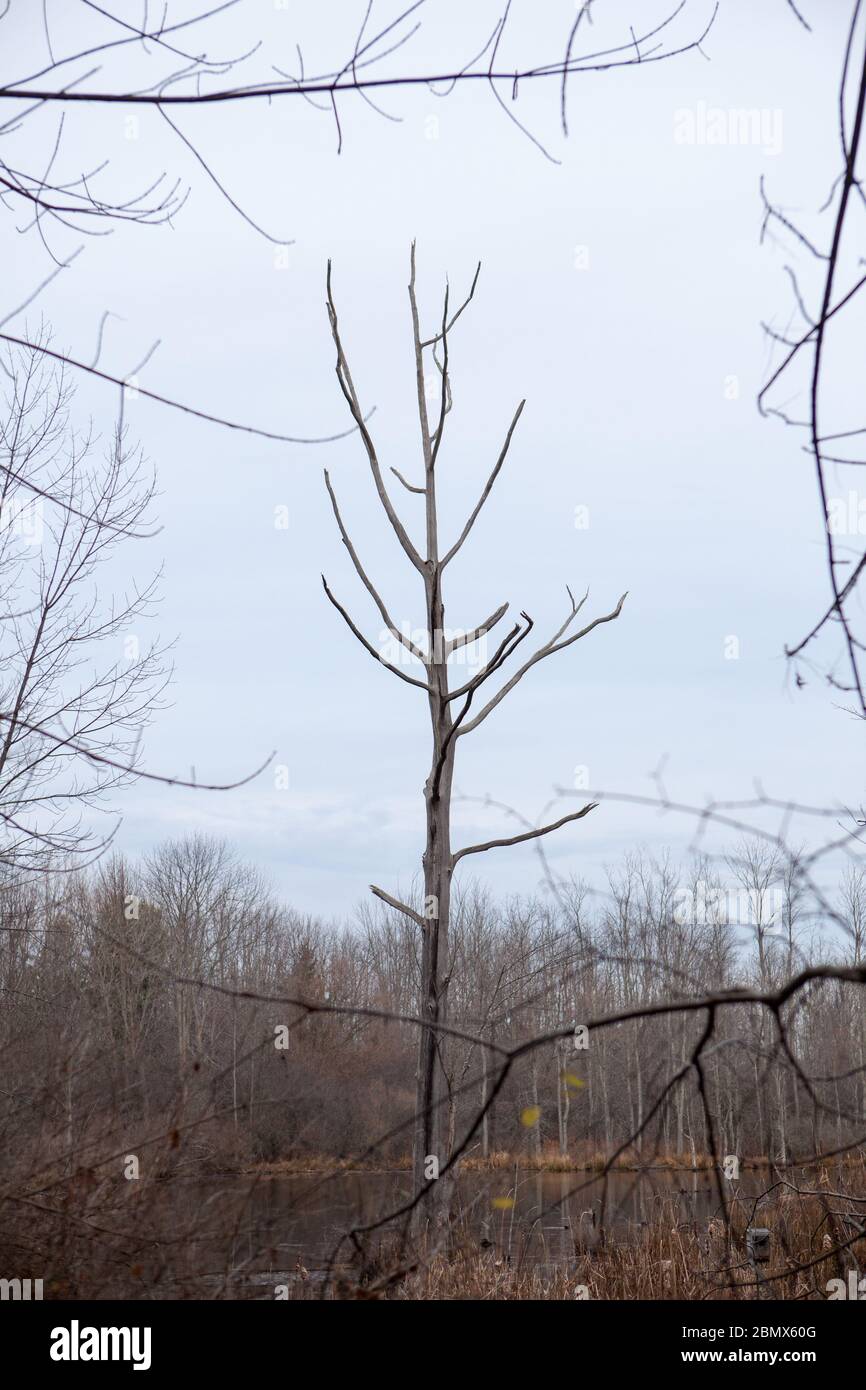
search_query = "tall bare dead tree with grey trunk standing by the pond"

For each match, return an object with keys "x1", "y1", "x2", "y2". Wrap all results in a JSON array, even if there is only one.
[{"x1": 322, "y1": 243, "x2": 626, "y2": 1209}]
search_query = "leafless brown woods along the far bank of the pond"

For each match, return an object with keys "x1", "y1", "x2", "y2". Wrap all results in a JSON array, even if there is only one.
[{"x1": 0, "y1": 835, "x2": 866, "y2": 1172}]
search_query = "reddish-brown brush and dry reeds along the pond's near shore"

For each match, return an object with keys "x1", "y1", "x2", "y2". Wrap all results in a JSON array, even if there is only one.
[{"x1": 0, "y1": 1140, "x2": 866, "y2": 1301}]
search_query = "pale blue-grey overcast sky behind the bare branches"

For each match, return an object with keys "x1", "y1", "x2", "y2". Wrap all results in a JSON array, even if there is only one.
[{"x1": 1, "y1": 0, "x2": 863, "y2": 915}]
